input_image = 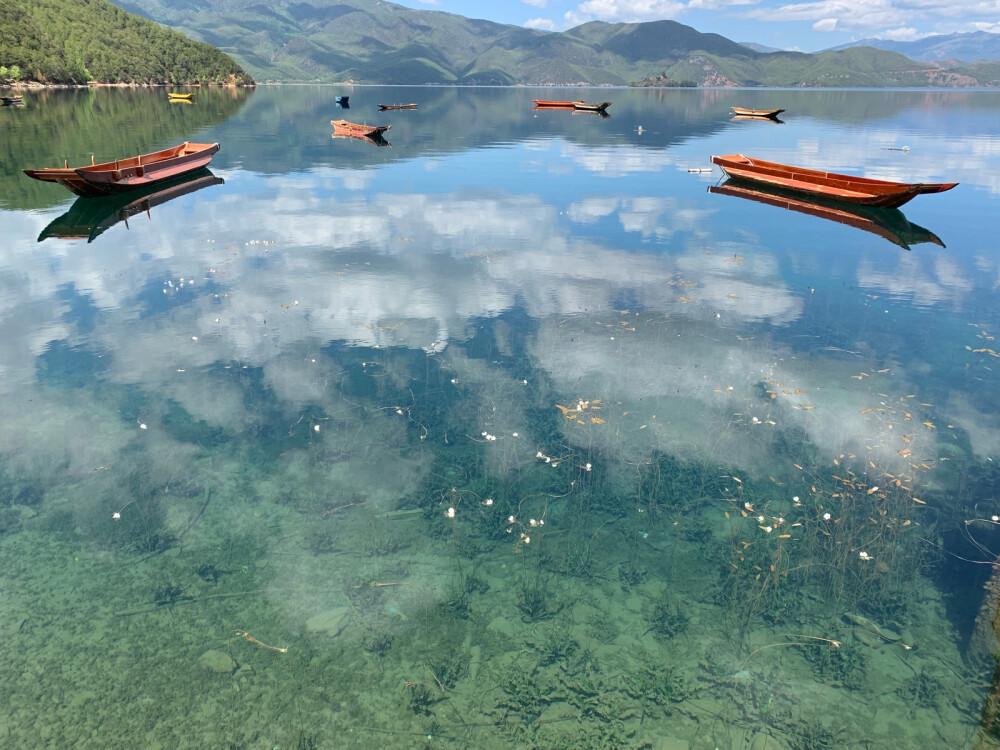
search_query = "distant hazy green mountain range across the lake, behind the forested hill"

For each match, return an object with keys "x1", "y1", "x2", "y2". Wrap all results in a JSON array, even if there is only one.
[{"x1": 107, "y1": 0, "x2": 1000, "y2": 87}]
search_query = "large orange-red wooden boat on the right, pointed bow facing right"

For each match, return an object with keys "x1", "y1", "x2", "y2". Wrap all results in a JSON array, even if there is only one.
[{"x1": 712, "y1": 154, "x2": 958, "y2": 208}]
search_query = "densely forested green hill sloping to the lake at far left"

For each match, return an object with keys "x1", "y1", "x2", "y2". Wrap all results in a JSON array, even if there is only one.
[{"x1": 0, "y1": 0, "x2": 253, "y2": 84}]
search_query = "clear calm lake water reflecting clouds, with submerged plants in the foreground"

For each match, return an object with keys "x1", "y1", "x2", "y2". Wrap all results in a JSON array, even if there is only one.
[{"x1": 0, "y1": 86, "x2": 1000, "y2": 750}]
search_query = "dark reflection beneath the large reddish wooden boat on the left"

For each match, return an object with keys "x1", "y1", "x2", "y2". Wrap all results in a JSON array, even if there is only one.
[{"x1": 38, "y1": 168, "x2": 225, "y2": 242}]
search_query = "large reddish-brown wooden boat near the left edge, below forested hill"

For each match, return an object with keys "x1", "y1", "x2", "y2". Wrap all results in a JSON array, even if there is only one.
[{"x1": 24, "y1": 142, "x2": 219, "y2": 198}]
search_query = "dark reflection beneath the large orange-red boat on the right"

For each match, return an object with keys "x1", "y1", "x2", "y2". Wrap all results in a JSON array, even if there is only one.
[{"x1": 708, "y1": 179, "x2": 945, "y2": 250}]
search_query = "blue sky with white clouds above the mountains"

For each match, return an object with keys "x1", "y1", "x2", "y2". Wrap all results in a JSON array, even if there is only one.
[{"x1": 395, "y1": 0, "x2": 1000, "y2": 52}]
